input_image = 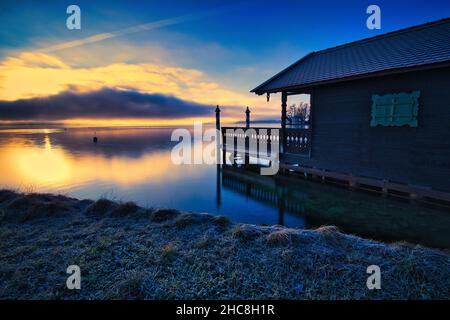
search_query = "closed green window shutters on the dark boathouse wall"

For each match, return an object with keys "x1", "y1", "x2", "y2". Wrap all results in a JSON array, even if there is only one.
[{"x1": 370, "y1": 91, "x2": 420, "y2": 127}]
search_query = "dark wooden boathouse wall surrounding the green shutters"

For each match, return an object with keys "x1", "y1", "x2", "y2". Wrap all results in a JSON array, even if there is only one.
[{"x1": 285, "y1": 67, "x2": 450, "y2": 192}]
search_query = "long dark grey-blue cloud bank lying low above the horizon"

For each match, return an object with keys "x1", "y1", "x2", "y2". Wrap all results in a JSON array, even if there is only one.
[{"x1": 0, "y1": 88, "x2": 214, "y2": 121}]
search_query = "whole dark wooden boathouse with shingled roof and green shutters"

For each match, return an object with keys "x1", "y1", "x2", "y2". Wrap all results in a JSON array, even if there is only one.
[{"x1": 222, "y1": 18, "x2": 450, "y2": 202}]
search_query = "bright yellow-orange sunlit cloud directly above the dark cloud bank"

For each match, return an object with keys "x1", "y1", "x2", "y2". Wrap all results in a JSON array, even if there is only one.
[{"x1": 0, "y1": 52, "x2": 261, "y2": 106}]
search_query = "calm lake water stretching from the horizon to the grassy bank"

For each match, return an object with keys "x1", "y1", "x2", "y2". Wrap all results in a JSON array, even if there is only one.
[{"x1": 0, "y1": 128, "x2": 450, "y2": 248}]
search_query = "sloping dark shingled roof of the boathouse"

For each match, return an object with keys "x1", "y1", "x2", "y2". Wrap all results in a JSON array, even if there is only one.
[{"x1": 251, "y1": 18, "x2": 450, "y2": 94}]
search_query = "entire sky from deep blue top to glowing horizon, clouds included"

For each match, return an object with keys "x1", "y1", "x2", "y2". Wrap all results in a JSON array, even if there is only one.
[{"x1": 0, "y1": 0, "x2": 450, "y2": 125}]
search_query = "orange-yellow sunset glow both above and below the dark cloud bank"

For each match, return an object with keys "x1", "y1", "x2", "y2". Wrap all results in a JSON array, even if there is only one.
[{"x1": 0, "y1": 52, "x2": 277, "y2": 126}]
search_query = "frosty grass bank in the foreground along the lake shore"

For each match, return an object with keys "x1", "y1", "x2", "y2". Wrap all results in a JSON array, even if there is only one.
[{"x1": 0, "y1": 191, "x2": 450, "y2": 299}]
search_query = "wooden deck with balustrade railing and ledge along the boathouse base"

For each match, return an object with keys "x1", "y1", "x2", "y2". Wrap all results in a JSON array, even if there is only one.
[{"x1": 222, "y1": 127, "x2": 450, "y2": 205}]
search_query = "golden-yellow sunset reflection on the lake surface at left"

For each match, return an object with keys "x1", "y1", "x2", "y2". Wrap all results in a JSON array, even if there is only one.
[{"x1": 0, "y1": 135, "x2": 199, "y2": 188}]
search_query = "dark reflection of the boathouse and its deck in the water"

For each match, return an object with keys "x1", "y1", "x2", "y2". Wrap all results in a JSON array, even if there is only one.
[{"x1": 222, "y1": 166, "x2": 450, "y2": 248}]
